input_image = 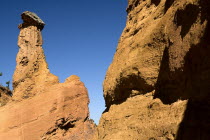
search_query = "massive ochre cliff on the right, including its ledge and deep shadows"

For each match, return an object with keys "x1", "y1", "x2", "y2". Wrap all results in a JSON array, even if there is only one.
[{"x1": 96, "y1": 0, "x2": 210, "y2": 140}]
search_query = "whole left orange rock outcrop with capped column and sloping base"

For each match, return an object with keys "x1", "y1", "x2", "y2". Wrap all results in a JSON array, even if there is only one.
[{"x1": 0, "y1": 12, "x2": 95, "y2": 140}]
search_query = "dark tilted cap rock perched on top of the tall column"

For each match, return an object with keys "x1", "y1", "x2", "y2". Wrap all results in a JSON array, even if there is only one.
[{"x1": 18, "y1": 11, "x2": 45, "y2": 30}]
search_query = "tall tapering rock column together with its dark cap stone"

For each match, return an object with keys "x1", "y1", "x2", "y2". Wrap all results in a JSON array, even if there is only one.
[{"x1": 13, "y1": 11, "x2": 58, "y2": 100}]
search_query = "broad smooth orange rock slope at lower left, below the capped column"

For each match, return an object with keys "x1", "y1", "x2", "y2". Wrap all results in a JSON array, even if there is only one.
[{"x1": 0, "y1": 76, "x2": 95, "y2": 140}]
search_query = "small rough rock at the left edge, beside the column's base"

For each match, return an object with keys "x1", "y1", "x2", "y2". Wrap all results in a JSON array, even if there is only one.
[{"x1": 0, "y1": 86, "x2": 12, "y2": 107}]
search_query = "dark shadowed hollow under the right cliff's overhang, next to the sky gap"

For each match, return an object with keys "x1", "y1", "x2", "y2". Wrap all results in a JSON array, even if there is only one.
[{"x1": 105, "y1": 68, "x2": 154, "y2": 109}]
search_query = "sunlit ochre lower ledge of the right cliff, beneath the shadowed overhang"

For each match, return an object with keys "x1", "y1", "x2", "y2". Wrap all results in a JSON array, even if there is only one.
[{"x1": 95, "y1": 93, "x2": 187, "y2": 140}]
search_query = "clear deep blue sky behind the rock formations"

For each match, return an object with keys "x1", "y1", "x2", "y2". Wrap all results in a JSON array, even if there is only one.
[{"x1": 0, "y1": 0, "x2": 127, "y2": 123}]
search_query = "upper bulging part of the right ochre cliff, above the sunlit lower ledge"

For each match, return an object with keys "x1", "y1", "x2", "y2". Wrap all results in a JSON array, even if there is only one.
[{"x1": 104, "y1": 0, "x2": 209, "y2": 107}]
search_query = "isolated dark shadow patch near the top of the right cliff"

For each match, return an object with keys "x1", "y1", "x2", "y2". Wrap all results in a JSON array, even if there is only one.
[{"x1": 174, "y1": 4, "x2": 200, "y2": 38}]
